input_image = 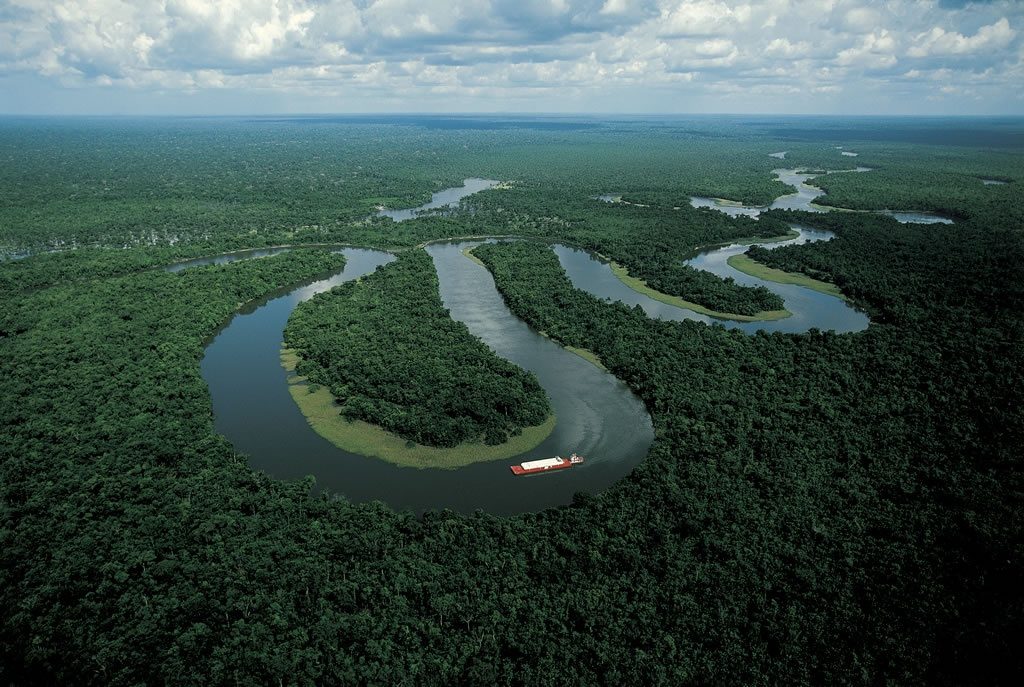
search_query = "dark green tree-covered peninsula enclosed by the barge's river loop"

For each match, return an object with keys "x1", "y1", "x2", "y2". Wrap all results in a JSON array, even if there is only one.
[{"x1": 285, "y1": 250, "x2": 551, "y2": 448}]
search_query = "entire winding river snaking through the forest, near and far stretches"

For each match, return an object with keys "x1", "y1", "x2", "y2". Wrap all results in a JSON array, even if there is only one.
[{"x1": 184, "y1": 168, "x2": 897, "y2": 514}]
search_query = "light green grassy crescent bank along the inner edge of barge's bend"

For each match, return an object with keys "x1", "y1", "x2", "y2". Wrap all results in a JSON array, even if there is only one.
[{"x1": 281, "y1": 349, "x2": 555, "y2": 470}]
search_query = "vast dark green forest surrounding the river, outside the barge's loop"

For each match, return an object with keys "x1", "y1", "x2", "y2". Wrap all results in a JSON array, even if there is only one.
[{"x1": 0, "y1": 118, "x2": 1024, "y2": 685}]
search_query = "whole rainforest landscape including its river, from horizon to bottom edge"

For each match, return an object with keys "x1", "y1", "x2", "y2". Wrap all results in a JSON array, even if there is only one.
[{"x1": 0, "y1": 116, "x2": 1024, "y2": 685}]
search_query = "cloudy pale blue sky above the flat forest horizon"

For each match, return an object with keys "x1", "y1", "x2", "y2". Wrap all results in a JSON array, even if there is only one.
[{"x1": 0, "y1": 0, "x2": 1024, "y2": 114}]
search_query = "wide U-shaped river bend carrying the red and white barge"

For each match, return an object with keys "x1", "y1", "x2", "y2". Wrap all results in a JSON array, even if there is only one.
[{"x1": 193, "y1": 244, "x2": 653, "y2": 514}]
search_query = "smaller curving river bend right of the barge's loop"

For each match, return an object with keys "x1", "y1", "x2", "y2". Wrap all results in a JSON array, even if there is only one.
[{"x1": 554, "y1": 226, "x2": 869, "y2": 334}]
